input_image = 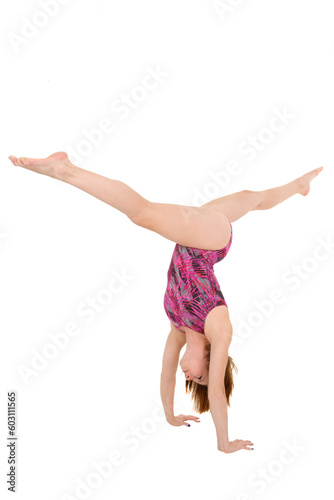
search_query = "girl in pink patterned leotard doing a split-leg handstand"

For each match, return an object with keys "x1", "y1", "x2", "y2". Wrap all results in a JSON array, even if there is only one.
[{"x1": 9, "y1": 152, "x2": 323, "y2": 453}]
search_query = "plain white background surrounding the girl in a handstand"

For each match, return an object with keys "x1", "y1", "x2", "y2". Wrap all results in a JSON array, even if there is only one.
[{"x1": 0, "y1": 0, "x2": 334, "y2": 500}]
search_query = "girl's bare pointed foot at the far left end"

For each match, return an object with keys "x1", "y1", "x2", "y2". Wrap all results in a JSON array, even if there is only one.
[{"x1": 8, "y1": 151, "x2": 74, "y2": 179}]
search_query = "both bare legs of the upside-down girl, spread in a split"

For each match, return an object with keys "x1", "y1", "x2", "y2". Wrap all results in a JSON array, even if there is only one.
[{"x1": 9, "y1": 152, "x2": 323, "y2": 244}]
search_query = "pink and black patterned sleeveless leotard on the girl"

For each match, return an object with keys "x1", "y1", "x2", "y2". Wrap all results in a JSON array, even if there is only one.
[{"x1": 164, "y1": 222, "x2": 232, "y2": 334}]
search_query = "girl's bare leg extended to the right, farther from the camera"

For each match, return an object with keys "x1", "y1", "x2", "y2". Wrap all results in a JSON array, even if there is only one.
[{"x1": 202, "y1": 167, "x2": 323, "y2": 222}]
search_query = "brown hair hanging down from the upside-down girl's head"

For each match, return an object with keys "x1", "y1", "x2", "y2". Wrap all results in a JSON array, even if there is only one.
[{"x1": 186, "y1": 342, "x2": 238, "y2": 413}]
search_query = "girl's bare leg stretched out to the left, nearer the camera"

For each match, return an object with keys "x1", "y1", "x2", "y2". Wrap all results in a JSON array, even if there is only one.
[{"x1": 9, "y1": 152, "x2": 231, "y2": 250}]
